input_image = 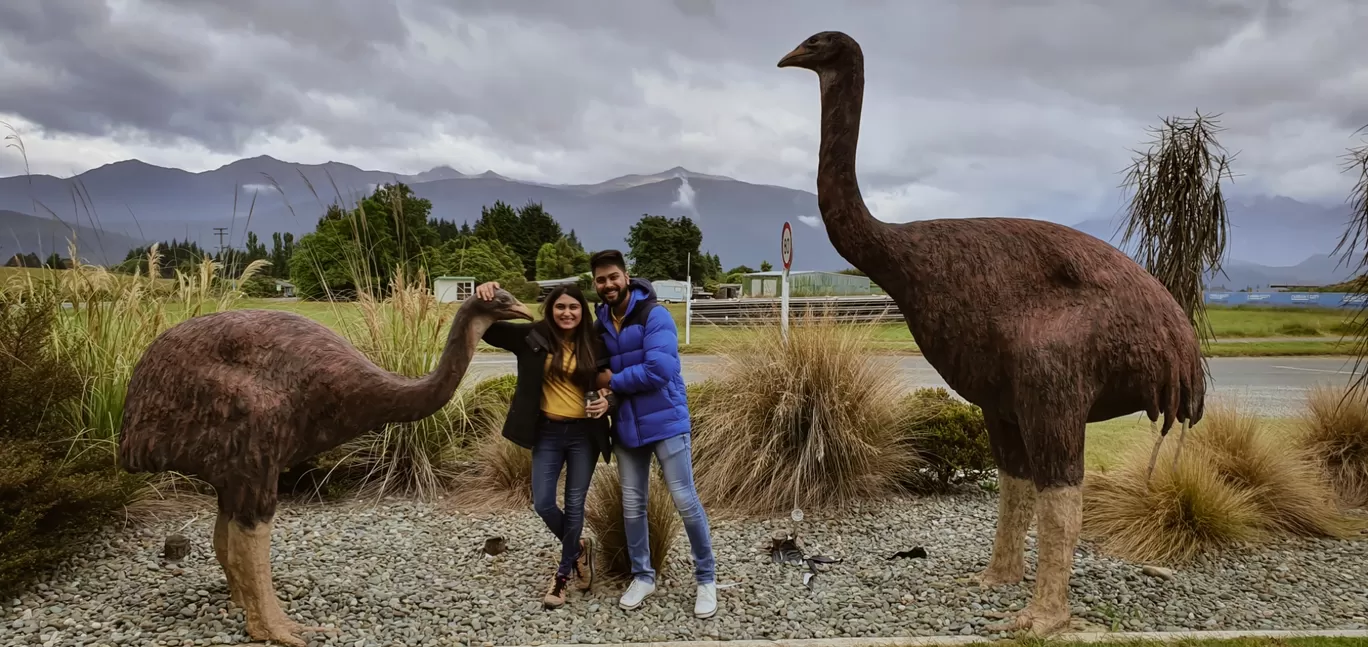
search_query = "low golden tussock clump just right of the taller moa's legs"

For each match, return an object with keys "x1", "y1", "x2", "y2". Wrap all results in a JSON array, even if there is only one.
[{"x1": 1083, "y1": 431, "x2": 1263, "y2": 564}]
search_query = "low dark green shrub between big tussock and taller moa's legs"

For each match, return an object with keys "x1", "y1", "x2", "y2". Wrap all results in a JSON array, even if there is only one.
[{"x1": 903, "y1": 388, "x2": 996, "y2": 492}]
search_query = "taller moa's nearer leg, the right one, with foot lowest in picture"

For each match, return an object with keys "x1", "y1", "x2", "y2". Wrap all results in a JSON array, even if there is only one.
[{"x1": 997, "y1": 404, "x2": 1086, "y2": 636}]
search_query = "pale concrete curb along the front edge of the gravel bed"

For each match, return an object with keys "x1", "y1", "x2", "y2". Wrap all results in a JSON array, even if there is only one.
[{"x1": 524, "y1": 629, "x2": 1368, "y2": 647}]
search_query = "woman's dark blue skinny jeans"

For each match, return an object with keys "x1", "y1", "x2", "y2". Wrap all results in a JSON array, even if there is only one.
[{"x1": 532, "y1": 417, "x2": 598, "y2": 577}]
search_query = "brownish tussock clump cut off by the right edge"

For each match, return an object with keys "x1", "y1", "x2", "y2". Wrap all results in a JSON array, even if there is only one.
[{"x1": 1298, "y1": 387, "x2": 1368, "y2": 507}]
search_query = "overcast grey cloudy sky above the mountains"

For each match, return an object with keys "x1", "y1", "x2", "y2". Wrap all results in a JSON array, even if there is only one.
[{"x1": 0, "y1": 0, "x2": 1368, "y2": 227}]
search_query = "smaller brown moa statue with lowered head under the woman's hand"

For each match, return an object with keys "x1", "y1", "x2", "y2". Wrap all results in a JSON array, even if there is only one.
[{"x1": 119, "y1": 290, "x2": 532, "y2": 647}]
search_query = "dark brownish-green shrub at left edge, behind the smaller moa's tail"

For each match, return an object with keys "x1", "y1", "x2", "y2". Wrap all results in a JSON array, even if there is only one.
[{"x1": 0, "y1": 290, "x2": 144, "y2": 595}]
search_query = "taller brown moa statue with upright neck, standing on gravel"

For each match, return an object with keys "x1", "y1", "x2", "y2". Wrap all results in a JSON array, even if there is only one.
[{"x1": 778, "y1": 31, "x2": 1205, "y2": 635}]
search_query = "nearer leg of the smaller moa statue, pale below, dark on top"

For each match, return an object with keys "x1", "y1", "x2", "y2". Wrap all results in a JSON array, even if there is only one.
[{"x1": 219, "y1": 476, "x2": 330, "y2": 647}]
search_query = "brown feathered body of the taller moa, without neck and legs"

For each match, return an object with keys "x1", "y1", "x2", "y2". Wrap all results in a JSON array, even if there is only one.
[{"x1": 859, "y1": 217, "x2": 1205, "y2": 431}]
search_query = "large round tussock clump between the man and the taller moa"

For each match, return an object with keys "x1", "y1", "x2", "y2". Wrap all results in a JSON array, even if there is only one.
[{"x1": 692, "y1": 315, "x2": 915, "y2": 514}]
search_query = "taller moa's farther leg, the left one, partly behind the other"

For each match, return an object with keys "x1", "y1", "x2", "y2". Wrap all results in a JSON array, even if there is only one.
[{"x1": 973, "y1": 414, "x2": 1036, "y2": 587}]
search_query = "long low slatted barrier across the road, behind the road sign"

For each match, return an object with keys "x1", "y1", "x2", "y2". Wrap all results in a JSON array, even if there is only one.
[{"x1": 689, "y1": 295, "x2": 903, "y2": 326}]
